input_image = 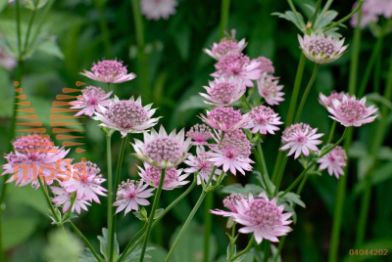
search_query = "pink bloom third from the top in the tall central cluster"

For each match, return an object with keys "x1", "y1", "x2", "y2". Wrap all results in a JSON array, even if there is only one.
[{"x1": 200, "y1": 77, "x2": 246, "y2": 106}]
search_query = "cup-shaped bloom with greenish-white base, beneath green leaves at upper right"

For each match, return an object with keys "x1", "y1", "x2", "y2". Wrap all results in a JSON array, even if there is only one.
[{"x1": 298, "y1": 34, "x2": 347, "y2": 64}]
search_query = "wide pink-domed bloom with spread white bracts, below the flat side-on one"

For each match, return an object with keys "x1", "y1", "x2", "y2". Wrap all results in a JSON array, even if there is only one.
[{"x1": 94, "y1": 97, "x2": 159, "y2": 137}]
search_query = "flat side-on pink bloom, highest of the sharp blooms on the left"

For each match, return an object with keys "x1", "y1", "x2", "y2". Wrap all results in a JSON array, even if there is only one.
[{"x1": 81, "y1": 60, "x2": 136, "y2": 84}]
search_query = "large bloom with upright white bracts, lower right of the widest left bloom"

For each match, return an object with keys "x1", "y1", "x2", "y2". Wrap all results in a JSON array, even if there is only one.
[{"x1": 133, "y1": 126, "x2": 191, "y2": 168}]
